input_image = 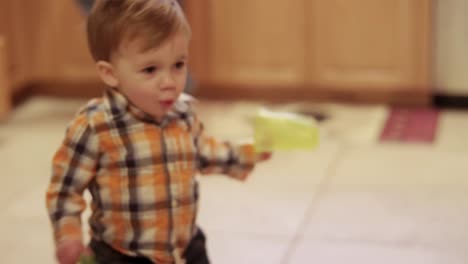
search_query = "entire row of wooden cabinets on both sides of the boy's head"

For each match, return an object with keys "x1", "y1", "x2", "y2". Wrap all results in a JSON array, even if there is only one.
[{"x1": 0, "y1": 0, "x2": 431, "y2": 107}]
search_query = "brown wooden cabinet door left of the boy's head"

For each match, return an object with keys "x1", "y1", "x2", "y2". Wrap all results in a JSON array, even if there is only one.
[{"x1": 35, "y1": 0, "x2": 97, "y2": 82}]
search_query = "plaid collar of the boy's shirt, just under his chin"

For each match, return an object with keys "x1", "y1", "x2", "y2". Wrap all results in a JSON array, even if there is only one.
[{"x1": 105, "y1": 88, "x2": 195, "y2": 124}]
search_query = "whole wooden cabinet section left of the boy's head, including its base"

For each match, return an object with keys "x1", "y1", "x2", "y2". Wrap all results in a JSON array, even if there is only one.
[{"x1": 0, "y1": 0, "x2": 101, "y2": 102}]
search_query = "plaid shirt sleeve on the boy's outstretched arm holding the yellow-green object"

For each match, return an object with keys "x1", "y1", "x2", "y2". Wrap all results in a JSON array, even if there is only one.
[{"x1": 193, "y1": 113, "x2": 256, "y2": 180}]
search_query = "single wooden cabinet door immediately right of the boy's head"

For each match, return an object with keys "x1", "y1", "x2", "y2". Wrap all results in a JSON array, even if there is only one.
[{"x1": 186, "y1": 0, "x2": 305, "y2": 85}]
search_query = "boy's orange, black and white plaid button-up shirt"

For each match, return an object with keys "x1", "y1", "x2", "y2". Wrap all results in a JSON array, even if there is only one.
[{"x1": 46, "y1": 89, "x2": 255, "y2": 263}]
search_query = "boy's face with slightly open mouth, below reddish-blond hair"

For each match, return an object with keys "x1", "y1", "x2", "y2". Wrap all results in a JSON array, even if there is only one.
[{"x1": 102, "y1": 32, "x2": 189, "y2": 120}]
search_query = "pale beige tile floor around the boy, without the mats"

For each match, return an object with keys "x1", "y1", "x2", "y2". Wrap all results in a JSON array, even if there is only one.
[{"x1": 0, "y1": 97, "x2": 468, "y2": 264}]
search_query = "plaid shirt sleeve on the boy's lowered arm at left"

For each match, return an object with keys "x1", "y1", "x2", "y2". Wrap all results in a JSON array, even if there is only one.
[{"x1": 46, "y1": 114, "x2": 98, "y2": 243}]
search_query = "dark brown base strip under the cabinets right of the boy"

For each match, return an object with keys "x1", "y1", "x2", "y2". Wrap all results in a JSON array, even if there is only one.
[{"x1": 195, "y1": 83, "x2": 431, "y2": 106}]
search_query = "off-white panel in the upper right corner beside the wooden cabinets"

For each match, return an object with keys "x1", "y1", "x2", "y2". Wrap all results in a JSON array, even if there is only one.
[{"x1": 433, "y1": 0, "x2": 468, "y2": 96}]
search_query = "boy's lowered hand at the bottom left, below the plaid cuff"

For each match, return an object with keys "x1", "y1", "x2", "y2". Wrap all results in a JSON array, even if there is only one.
[{"x1": 56, "y1": 240, "x2": 92, "y2": 264}]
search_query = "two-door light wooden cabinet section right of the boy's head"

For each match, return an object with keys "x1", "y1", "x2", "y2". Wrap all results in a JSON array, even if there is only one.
[{"x1": 187, "y1": 0, "x2": 431, "y2": 103}]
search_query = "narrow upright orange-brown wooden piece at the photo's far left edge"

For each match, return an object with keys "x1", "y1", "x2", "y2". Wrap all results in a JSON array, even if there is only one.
[{"x1": 0, "y1": 36, "x2": 12, "y2": 120}]
